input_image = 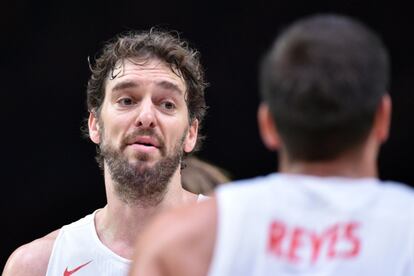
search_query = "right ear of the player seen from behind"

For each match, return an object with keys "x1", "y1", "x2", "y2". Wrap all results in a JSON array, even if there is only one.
[{"x1": 374, "y1": 94, "x2": 392, "y2": 143}]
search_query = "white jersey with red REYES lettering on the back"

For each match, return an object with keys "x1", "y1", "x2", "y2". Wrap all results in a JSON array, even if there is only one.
[{"x1": 209, "y1": 174, "x2": 414, "y2": 276}]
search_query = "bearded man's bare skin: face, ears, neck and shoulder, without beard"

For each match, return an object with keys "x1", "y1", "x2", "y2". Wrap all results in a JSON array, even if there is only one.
[{"x1": 2, "y1": 59, "x2": 198, "y2": 276}]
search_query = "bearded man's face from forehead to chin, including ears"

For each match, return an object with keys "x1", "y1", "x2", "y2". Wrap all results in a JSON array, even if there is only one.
[{"x1": 90, "y1": 59, "x2": 198, "y2": 169}]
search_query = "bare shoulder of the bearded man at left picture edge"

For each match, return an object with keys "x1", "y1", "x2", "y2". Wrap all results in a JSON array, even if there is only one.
[{"x1": 2, "y1": 230, "x2": 59, "y2": 276}]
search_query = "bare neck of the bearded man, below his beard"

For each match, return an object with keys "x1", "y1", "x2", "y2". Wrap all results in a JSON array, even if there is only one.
[{"x1": 95, "y1": 168, "x2": 197, "y2": 259}]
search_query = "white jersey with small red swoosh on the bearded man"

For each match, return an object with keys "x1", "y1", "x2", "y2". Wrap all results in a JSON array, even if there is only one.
[{"x1": 46, "y1": 195, "x2": 207, "y2": 276}]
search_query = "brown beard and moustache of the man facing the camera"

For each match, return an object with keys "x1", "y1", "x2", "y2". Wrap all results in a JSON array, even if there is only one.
[{"x1": 99, "y1": 129, "x2": 186, "y2": 207}]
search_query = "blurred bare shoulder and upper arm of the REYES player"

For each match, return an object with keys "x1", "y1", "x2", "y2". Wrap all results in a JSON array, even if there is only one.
[{"x1": 130, "y1": 198, "x2": 217, "y2": 276}]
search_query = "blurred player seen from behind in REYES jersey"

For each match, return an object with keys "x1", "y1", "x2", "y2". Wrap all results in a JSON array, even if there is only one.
[{"x1": 131, "y1": 15, "x2": 414, "y2": 276}]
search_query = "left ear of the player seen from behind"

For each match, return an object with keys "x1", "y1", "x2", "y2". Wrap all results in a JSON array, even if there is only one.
[{"x1": 257, "y1": 103, "x2": 280, "y2": 151}]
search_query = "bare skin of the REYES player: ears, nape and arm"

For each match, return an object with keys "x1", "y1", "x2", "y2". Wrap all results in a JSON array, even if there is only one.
[{"x1": 130, "y1": 95, "x2": 391, "y2": 276}]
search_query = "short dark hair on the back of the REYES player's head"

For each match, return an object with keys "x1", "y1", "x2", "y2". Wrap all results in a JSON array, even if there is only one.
[{"x1": 261, "y1": 14, "x2": 389, "y2": 161}]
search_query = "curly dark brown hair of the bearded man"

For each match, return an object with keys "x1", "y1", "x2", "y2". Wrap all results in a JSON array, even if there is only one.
[{"x1": 84, "y1": 28, "x2": 207, "y2": 150}]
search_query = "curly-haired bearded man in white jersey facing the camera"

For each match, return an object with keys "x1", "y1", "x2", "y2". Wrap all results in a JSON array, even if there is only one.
[{"x1": 3, "y1": 30, "x2": 206, "y2": 276}]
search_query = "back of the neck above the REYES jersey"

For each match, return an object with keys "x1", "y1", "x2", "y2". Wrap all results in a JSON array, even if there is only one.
[{"x1": 279, "y1": 141, "x2": 378, "y2": 178}]
